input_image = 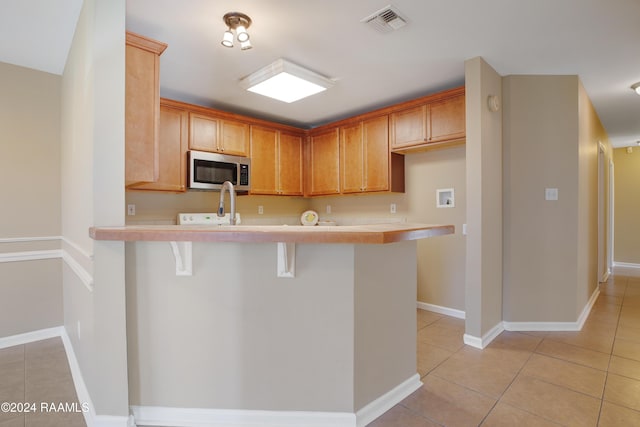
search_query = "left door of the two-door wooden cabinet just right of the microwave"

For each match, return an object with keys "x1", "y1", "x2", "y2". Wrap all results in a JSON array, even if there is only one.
[{"x1": 251, "y1": 126, "x2": 278, "y2": 194}]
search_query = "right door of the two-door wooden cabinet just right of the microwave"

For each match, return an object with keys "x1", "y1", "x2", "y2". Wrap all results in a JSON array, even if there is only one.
[{"x1": 278, "y1": 132, "x2": 303, "y2": 196}]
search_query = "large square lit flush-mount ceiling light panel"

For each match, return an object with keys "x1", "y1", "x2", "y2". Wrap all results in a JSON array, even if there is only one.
[{"x1": 240, "y1": 59, "x2": 333, "y2": 103}]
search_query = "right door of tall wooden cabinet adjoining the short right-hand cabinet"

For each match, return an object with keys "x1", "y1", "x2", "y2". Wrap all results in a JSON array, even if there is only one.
[{"x1": 362, "y1": 116, "x2": 389, "y2": 191}]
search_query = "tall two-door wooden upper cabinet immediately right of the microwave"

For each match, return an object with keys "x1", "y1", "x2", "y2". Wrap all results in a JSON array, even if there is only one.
[{"x1": 251, "y1": 125, "x2": 303, "y2": 196}]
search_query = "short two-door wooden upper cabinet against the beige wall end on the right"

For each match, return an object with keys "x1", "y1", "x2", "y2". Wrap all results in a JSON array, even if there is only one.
[{"x1": 391, "y1": 87, "x2": 466, "y2": 153}]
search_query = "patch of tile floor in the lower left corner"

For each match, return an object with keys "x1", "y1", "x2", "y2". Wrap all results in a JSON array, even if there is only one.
[{"x1": 0, "y1": 338, "x2": 86, "y2": 427}]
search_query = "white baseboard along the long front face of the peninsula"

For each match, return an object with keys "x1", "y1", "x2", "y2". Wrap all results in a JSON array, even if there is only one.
[{"x1": 131, "y1": 406, "x2": 356, "y2": 427}]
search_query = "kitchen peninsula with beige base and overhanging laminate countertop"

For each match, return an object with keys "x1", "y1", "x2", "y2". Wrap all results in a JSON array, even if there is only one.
[{"x1": 90, "y1": 223, "x2": 454, "y2": 427}]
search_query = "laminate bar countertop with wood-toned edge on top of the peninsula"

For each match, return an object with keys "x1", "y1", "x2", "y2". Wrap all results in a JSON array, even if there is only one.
[{"x1": 89, "y1": 223, "x2": 455, "y2": 244}]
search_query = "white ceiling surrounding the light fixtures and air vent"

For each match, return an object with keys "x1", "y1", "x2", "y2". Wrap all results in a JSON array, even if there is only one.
[{"x1": 0, "y1": 0, "x2": 640, "y2": 146}]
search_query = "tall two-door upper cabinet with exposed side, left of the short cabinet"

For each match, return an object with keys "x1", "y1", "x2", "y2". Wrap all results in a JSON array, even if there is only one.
[{"x1": 340, "y1": 115, "x2": 404, "y2": 193}]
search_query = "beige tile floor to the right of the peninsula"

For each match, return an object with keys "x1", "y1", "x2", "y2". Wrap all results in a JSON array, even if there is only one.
[{"x1": 369, "y1": 277, "x2": 640, "y2": 427}]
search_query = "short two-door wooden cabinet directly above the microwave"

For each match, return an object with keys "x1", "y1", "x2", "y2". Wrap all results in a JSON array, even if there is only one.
[{"x1": 189, "y1": 112, "x2": 250, "y2": 157}]
